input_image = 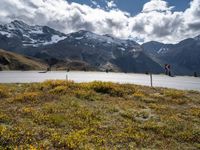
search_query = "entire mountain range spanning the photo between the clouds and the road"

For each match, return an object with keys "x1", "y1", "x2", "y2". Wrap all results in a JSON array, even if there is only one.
[{"x1": 0, "y1": 20, "x2": 200, "y2": 74}]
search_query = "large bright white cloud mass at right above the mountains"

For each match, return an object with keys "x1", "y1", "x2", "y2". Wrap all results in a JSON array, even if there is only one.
[{"x1": 130, "y1": 0, "x2": 200, "y2": 43}]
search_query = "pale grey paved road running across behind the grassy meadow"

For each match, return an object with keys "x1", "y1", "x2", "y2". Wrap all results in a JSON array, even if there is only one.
[{"x1": 0, "y1": 71, "x2": 200, "y2": 91}]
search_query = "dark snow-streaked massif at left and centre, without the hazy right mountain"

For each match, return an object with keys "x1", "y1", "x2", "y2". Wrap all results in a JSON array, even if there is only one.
[{"x1": 0, "y1": 21, "x2": 162, "y2": 73}]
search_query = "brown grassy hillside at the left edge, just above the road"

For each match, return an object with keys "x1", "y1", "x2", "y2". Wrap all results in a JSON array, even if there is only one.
[{"x1": 0, "y1": 49, "x2": 47, "y2": 70}]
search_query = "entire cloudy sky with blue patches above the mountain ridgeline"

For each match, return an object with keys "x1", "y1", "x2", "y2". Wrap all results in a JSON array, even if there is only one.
[{"x1": 0, "y1": 0, "x2": 200, "y2": 43}]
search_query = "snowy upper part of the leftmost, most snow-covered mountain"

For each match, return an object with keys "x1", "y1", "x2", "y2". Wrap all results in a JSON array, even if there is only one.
[{"x1": 0, "y1": 20, "x2": 66, "y2": 47}]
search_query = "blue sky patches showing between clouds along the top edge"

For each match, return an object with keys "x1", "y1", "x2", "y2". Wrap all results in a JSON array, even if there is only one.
[{"x1": 67, "y1": 0, "x2": 191, "y2": 15}]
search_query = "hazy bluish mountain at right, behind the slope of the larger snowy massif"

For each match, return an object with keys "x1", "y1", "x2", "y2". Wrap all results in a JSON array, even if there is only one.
[{"x1": 142, "y1": 36, "x2": 200, "y2": 75}]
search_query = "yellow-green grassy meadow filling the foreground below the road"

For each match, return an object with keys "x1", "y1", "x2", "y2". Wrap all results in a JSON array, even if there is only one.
[{"x1": 0, "y1": 81, "x2": 200, "y2": 150}]
